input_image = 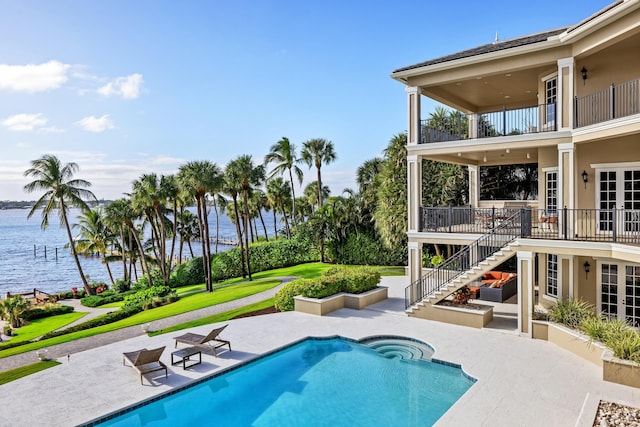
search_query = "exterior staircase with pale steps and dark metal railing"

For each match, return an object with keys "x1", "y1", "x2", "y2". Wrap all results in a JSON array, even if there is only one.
[{"x1": 405, "y1": 211, "x2": 523, "y2": 318}]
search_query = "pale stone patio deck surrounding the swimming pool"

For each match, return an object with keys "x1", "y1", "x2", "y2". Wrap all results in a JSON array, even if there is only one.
[{"x1": 0, "y1": 277, "x2": 640, "y2": 426}]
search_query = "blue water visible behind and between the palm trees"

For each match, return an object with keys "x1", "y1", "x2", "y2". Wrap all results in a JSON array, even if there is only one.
[{"x1": 0, "y1": 209, "x2": 273, "y2": 298}]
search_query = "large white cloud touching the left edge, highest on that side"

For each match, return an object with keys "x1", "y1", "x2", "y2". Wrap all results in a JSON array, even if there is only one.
[{"x1": 0, "y1": 61, "x2": 71, "y2": 93}]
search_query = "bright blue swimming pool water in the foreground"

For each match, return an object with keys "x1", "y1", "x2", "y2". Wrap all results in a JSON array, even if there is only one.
[{"x1": 92, "y1": 338, "x2": 475, "y2": 427}]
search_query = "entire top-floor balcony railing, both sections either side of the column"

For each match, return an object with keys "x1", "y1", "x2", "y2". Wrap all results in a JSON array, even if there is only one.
[{"x1": 419, "y1": 79, "x2": 640, "y2": 144}]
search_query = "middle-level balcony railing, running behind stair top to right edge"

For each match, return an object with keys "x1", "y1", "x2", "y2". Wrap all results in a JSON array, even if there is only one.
[{"x1": 420, "y1": 206, "x2": 640, "y2": 245}]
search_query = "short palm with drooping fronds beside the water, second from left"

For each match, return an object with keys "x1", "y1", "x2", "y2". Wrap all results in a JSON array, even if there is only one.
[{"x1": 74, "y1": 208, "x2": 115, "y2": 285}]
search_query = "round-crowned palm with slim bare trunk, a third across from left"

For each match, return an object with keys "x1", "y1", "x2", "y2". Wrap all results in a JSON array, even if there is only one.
[{"x1": 178, "y1": 161, "x2": 222, "y2": 292}]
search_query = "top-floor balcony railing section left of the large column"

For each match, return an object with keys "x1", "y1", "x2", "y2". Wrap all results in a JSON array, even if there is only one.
[{"x1": 420, "y1": 104, "x2": 556, "y2": 144}]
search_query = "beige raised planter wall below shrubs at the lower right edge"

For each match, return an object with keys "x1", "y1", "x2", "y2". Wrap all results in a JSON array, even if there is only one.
[{"x1": 533, "y1": 320, "x2": 640, "y2": 388}]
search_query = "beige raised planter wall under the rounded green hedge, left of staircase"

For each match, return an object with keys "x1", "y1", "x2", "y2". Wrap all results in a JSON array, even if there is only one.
[{"x1": 293, "y1": 286, "x2": 389, "y2": 316}]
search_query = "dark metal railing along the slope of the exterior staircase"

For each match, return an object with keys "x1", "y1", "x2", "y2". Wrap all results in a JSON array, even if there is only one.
[{"x1": 404, "y1": 210, "x2": 526, "y2": 309}]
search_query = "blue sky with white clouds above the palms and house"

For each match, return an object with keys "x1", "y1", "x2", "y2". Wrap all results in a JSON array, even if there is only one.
[{"x1": 0, "y1": 0, "x2": 612, "y2": 200}]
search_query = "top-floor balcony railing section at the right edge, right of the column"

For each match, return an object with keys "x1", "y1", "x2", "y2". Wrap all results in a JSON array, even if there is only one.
[{"x1": 574, "y1": 79, "x2": 640, "y2": 128}]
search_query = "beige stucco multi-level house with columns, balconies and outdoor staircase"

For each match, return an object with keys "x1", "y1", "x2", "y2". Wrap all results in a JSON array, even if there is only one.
[{"x1": 391, "y1": 0, "x2": 640, "y2": 335}]
